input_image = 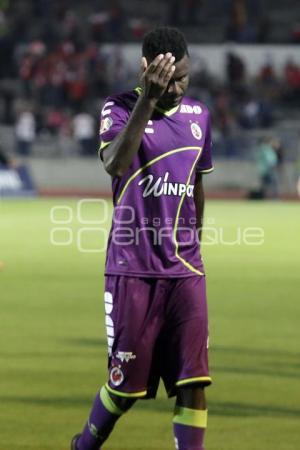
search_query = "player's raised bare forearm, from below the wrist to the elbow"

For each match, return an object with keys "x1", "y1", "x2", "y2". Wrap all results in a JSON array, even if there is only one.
[{"x1": 103, "y1": 96, "x2": 156, "y2": 177}]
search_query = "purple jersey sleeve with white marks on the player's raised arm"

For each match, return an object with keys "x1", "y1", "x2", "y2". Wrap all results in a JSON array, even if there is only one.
[{"x1": 99, "y1": 98, "x2": 129, "y2": 159}]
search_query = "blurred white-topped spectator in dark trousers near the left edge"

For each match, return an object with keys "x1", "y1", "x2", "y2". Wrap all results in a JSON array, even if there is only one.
[{"x1": 15, "y1": 110, "x2": 36, "y2": 156}]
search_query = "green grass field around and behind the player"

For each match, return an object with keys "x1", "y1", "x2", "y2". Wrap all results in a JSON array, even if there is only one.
[{"x1": 0, "y1": 199, "x2": 300, "y2": 450}]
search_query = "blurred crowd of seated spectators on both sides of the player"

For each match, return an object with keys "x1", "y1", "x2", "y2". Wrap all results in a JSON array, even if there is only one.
[{"x1": 0, "y1": 42, "x2": 300, "y2": 156}]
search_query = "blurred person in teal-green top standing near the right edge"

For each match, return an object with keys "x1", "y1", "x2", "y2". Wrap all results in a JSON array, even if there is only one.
[{"x1": 256, "y1": 137, "x2": 278, "y2": 198}]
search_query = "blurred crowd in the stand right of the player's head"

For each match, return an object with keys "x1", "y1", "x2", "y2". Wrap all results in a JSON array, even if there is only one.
[{"x1": 191, "y1": 52, "x2": 300, "y2": 136}]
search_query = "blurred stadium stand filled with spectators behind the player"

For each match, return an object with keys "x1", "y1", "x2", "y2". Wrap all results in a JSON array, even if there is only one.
[{"x1": 0, "y1": 0, "x2": 300, "y2": 196}]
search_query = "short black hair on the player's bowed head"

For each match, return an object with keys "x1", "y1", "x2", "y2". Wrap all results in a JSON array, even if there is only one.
[{"x1": 142, "y1": 27, "x2": 189, "y2": 62}]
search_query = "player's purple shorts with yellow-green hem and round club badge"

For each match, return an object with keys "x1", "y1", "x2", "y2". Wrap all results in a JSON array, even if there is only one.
[{"x1": 104, "y1": 275, "x2": 211, "y2": 398}]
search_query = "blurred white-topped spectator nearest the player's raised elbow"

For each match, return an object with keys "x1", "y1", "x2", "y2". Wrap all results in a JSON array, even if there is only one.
[{"x1": 73, "y1": 112, "x2": 97, "y2": 156}]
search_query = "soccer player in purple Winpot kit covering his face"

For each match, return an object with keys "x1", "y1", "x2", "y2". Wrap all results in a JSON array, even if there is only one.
[{"x1": 71, "y1": 27, "x2": 213, "y2": 450}]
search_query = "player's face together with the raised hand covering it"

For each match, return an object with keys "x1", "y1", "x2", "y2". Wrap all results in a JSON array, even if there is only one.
[{"x1": 141, "y1": 53, "x2": 189, "y2": 109}]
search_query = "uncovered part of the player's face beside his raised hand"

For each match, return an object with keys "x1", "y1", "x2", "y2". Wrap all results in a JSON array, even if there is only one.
[{"x1": 158, "y1": 55, "x2": 189, "y2": 109}]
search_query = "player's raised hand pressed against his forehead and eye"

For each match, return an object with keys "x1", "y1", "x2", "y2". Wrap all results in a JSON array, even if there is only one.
[{"x1": 140, "y1": 53, "x2": 175, "y2": 101}]
